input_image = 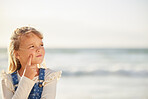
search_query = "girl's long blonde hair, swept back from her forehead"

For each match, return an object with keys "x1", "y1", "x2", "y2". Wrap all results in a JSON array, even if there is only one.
[{"x1": 8, "y1": 27, "x2": 43, "y2": 73}]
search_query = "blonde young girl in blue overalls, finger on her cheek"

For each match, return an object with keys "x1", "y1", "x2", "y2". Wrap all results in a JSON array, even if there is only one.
[{"x1": 2, "y1": 27, "x2": 61, "y2": 99}]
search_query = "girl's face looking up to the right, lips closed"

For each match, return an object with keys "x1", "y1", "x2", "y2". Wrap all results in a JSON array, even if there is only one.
[{"x1": 16, "y1": 33, "x2": 45, "y2": 66}]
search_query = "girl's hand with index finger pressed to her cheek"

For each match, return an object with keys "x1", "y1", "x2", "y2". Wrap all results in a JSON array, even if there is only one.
[{"x1": 23, "y1": 55, "x2": 38, "y2": 80}]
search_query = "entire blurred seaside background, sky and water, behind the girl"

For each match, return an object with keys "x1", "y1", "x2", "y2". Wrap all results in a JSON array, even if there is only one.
[{"x1": 0, "y1": 0, "x2": 148, "y2": 99}]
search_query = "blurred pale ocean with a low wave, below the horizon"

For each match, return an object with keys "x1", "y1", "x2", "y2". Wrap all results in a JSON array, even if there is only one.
[{"x1": 0, "y1": 49, "x2": 148, "y2": 99}]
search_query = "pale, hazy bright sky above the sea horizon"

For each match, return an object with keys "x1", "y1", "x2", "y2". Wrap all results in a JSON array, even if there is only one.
[{"x1": 0, "y1": 0, "x2": 148, "y2": 48}]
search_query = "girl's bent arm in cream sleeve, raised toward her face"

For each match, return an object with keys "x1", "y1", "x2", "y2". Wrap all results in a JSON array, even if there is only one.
[{"x1": 1, "y1": 76, "x2": 35, "y2": 99}]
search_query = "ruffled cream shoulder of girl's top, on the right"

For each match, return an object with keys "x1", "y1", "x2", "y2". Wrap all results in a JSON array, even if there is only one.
[{"x1": 44, "y1": 68, "x2": 62, "y2": 83}]
